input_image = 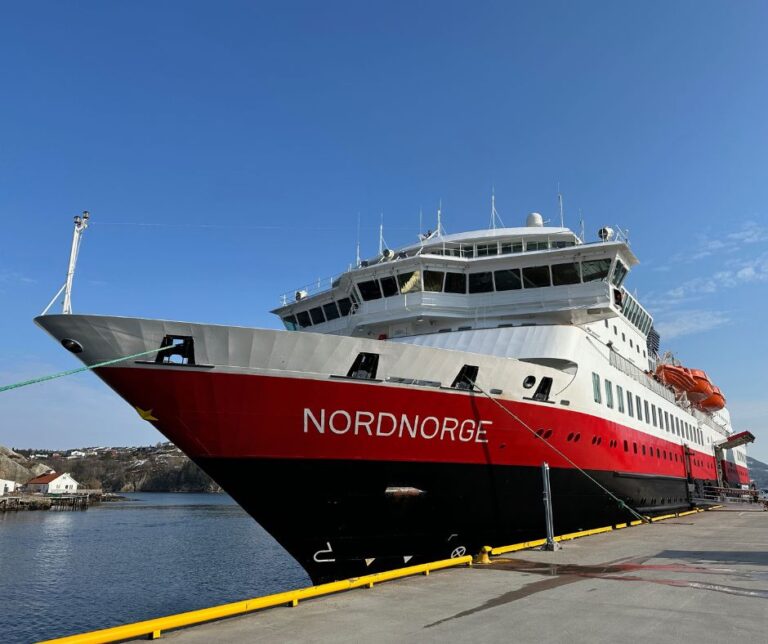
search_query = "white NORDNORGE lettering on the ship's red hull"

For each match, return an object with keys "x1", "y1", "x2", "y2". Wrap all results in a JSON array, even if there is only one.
[{"x1": 304, "y1": 407, "x2": 493, "y2": 443}]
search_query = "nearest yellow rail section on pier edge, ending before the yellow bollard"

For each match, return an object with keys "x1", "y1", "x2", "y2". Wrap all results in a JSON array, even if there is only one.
[{"x1": 39, "y1": 555, "x2": 472, "y2": 644}]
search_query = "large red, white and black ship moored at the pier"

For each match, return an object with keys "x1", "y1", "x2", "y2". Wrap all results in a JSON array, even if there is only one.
[{"x1": 36, "y1": 213, "x2": 753, "y2": 582}]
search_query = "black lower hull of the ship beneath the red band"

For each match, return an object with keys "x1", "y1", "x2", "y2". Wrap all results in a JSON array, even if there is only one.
[{"x1": 196, "y1": 458, "x2": 708, "y2": 583}]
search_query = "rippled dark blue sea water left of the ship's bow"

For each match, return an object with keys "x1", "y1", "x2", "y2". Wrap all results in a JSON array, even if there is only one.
[{"x1": 0, "y1": 493, "x2": 311, "y2": 644}]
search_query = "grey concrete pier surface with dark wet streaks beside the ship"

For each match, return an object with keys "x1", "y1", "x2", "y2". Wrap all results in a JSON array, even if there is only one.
[{"x1": 152, "y1": 506, "x2": 768, "y2": 644}]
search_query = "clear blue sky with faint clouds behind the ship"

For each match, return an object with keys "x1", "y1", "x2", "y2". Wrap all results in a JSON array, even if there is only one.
[{"x1": 0, "y1": 0, "x2": 768, "y2": 460}]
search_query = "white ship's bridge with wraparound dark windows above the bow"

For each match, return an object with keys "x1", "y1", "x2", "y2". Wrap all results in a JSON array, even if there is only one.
[{"x1": 273, "y1": 218, "x2": 638, "y2": 338}]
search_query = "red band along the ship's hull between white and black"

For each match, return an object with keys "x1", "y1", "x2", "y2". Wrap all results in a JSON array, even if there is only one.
[{"x1": 99, "y1": 368, "x2": 744, "y2": 482}]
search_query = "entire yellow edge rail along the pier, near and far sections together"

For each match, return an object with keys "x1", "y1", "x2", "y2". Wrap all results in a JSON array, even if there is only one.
[{"x1": 38, "y1": 506, "x2": 722, "y2": 644}]
